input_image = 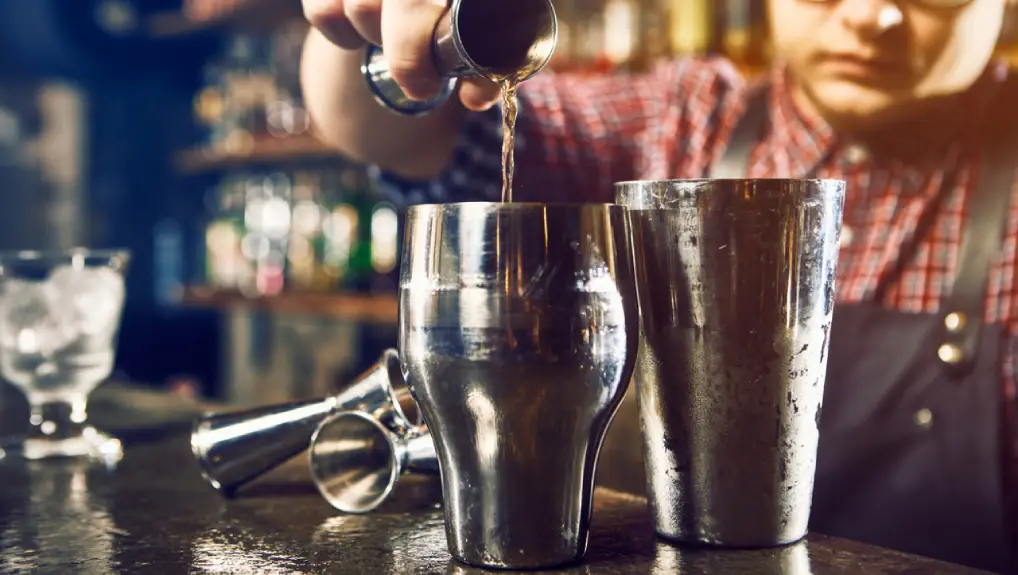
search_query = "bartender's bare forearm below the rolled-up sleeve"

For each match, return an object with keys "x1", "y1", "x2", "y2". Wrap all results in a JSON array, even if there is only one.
[{"x1": 300, "y1": 28, "x2": 465, "y2": 179}]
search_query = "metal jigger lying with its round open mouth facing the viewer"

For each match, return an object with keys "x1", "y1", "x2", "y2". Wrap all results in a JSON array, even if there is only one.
[{"x1": 307, "y1": 411, "x2": 439, "y2": 513}]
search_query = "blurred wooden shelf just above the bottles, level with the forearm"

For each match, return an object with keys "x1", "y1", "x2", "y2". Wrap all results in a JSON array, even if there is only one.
[{"x1": 174, "y1": 136, "x2": 341, "y2": 174}]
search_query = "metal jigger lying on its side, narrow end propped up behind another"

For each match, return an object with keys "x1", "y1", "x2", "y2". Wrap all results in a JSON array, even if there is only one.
[{"x1": 191, "y1": 349, "x2": 420, "y2": 497}]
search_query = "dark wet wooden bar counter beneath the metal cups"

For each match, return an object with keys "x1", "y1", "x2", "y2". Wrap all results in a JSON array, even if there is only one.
[{"x1": 0, "y1": 382, "x2": 997, "y2": 575}]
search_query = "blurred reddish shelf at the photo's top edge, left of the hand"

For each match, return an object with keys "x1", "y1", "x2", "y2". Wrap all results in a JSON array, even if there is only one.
[{"x1": 148, "y1": 0, "x2": 301, "y2": 39}]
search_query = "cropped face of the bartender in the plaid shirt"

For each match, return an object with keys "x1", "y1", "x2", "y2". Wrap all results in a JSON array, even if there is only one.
[{"x1": 770, "y1": 0, "x2": 1014, "y2": 123}]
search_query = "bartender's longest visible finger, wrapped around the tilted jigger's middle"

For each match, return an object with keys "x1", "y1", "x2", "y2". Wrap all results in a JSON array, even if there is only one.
[{"x1": 382, "y1": 0, "x2": 445, "y2": 101}]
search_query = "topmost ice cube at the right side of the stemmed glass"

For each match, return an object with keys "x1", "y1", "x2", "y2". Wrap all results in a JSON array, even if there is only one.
[{"x1": 47, "y1": 266, "x2": 124, "y2": 336}]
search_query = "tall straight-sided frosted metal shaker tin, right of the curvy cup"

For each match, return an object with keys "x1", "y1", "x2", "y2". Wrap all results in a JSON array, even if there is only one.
[{"x1": 616, "y1": 179, "x2": 845, "y2": 547}]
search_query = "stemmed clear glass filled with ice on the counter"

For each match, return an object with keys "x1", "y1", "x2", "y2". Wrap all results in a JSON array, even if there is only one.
[{"x1": 0, "y1": 249, "x2": 129, "y2": 460}]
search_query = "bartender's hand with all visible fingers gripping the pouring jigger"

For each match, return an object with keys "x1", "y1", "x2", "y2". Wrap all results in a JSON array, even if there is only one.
[{"x1": 303, "y1": 0, "x2": 499, "y2": 110}]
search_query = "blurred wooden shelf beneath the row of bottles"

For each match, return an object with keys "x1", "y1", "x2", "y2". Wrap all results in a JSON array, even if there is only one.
[{"x1": 181, "y1": 286, "x2": 399, "y2": 326}]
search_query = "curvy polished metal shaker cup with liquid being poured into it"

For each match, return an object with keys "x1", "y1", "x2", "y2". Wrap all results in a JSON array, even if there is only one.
[{"x1": 399, "y1": 203, "x2": 639, "y2": 569}]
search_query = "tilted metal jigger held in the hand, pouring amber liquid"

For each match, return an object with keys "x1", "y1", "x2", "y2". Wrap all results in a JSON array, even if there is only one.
[{"x1": 360, "y1": 0, "x2": 559, "y2": 116}]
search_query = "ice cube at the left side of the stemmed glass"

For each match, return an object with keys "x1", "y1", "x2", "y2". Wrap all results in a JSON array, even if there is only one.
[{"x1": 0, "y1": 280, "x2": 77, "y2": 356}]
